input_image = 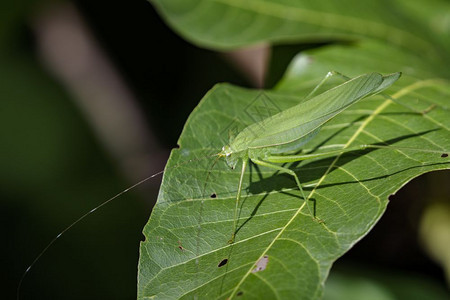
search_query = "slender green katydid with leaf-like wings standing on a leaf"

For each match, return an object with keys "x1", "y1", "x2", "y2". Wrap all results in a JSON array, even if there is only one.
[{"x1": 214, "y1": 73, "x2": 401, "y2": 243}]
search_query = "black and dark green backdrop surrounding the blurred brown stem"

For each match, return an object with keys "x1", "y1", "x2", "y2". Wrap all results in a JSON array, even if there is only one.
[{"x1": 0, "y1": 0, "x2": 448, "y2": 299}]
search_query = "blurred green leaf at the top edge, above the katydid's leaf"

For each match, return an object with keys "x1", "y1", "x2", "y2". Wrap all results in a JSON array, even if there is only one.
[{"x1": 149, "y1": 0, "x2": 450, "y2": 67}]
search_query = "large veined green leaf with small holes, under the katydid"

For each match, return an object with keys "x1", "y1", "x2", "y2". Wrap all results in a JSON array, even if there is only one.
[{"x1": 138, "y1": 42, "x2": 450, "y2": 299}]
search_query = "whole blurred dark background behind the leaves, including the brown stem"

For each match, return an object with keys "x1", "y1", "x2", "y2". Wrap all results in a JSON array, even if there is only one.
[{"x1": 0, "y1": 0, "x2": 450, "y2": 299}]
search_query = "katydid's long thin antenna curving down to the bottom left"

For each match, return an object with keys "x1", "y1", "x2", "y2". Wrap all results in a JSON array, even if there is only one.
[{"x1": 17, "y1": 153, "x2": 218, "y2": 300}]
